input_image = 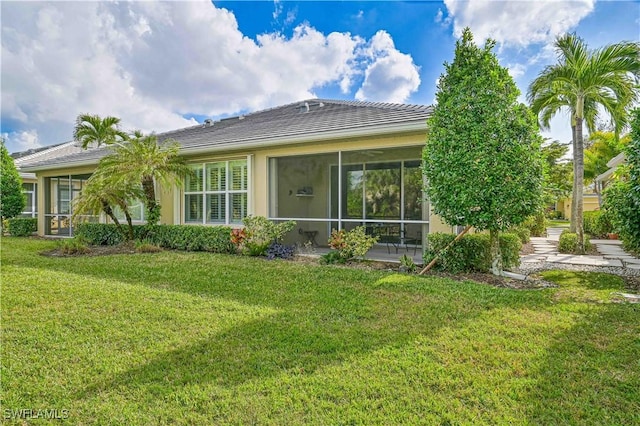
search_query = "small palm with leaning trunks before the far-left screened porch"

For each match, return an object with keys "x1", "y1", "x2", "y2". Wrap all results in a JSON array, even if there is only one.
[{"x1": 72, "y1": 169, "x2": 142, "y2": 240}]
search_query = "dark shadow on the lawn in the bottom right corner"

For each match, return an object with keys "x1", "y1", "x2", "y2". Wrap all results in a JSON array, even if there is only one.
[{"x1": 527, "y1": 298, "x2": 640, "y2": 424}]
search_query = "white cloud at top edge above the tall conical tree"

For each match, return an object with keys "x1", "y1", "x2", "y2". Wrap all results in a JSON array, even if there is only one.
[{"x1": 444, "y1": 0, "x2": 595, "y2": 47}]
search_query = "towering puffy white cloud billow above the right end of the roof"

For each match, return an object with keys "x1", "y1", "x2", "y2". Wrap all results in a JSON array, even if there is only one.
[{"x1": 356, "y1": 31, "x2": 420, "y2": 102}]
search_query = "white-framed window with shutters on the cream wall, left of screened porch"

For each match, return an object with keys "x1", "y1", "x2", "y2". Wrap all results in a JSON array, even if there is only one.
[{"x1": 184, "y1": 160, "x2": 249, "y2": 224}]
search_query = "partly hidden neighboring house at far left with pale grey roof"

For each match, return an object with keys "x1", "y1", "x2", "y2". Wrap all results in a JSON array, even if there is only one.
[{"x1": 11, "y1": 142, "x2": 82, "y2": 217}]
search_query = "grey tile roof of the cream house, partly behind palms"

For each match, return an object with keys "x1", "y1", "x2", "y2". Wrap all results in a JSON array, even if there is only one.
[{"x1": 20, "y1": 99, "x2": 432, "y2": 170}]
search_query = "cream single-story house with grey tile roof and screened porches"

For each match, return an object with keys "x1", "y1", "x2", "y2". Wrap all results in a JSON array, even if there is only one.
[{"x1": 21, "y1": 99, "x2": 452, "y2": 253}]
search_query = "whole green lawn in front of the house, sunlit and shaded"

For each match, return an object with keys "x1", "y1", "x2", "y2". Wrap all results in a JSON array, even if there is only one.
[{"x1": 1, "y1": 238, "x2": 640, "y2": 425}]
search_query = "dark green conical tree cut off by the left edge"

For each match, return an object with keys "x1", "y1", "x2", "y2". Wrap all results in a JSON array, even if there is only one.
[{"x1": 0, "y1": 139, "x2": 26, "y2": 220}]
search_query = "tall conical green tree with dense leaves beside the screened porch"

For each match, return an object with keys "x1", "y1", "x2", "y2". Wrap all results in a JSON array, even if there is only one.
[{"x1": 423, "y1": 28, "x2": 542, "y2": 274}]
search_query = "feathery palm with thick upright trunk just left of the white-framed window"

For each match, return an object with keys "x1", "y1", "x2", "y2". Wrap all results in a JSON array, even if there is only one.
[{"x1": 100, "y1": 131, "x2": 191, "y2": 224}]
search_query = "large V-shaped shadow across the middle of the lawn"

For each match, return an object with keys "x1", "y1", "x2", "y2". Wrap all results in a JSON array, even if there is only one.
[{"x1": 3, "y1": 238, "x2": 551, "y2": 408}]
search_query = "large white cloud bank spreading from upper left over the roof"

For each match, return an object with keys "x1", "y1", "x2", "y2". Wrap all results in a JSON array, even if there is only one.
[{"x1": 2, "y1": 0, "x2": 420, "y2": 153}]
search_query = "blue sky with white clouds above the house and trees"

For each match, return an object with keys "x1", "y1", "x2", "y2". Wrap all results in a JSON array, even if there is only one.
[{"x1": 0, "y1": 0, "x2": 640, "y2": 152}]
